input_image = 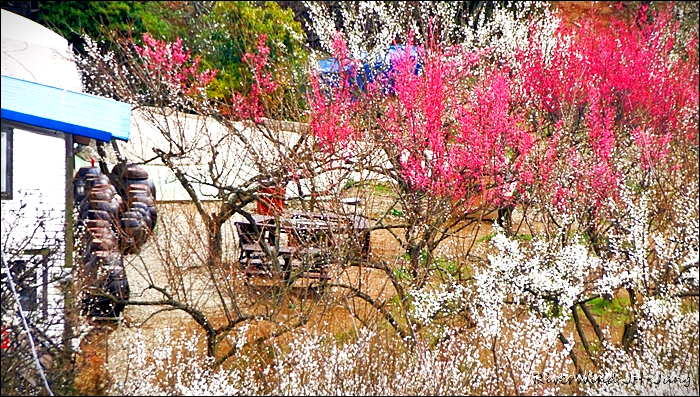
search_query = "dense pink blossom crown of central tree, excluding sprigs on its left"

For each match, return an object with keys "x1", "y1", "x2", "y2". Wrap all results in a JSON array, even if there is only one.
[{"x1": 381, "y1": 39, "x2": 532, "y2": 207}]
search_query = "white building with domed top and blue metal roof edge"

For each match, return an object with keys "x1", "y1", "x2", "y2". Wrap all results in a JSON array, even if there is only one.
[{"x1": 0, "y1": 10, "x2": 131, "y2": 344}]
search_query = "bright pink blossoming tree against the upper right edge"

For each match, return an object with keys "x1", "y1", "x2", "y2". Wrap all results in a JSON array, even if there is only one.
[{"x1": 513, "y1": 1, "x2": 698, "y2": 251}]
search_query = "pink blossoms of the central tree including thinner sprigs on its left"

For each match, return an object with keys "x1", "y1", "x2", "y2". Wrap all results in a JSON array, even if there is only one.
[{"x1": 310, "y1": 32, "x2": 533, "y2": 209}]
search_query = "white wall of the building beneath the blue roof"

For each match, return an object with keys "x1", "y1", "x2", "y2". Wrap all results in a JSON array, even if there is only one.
[{"x1": 1, "y1": 128, "x2": 67, "y2": 337}]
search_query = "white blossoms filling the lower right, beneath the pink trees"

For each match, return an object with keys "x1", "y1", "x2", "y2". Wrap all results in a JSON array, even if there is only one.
[{"x1": 468, "y1": 186, "x2": 699, "y2": 395}]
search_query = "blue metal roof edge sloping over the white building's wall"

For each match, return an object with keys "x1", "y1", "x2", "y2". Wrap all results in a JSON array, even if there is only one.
[{"x1": 2, "y1": 76, "x2": 131, "y2": 141}]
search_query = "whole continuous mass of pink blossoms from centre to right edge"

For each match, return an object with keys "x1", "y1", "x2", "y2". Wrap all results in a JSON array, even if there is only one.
[{"x1": 309, "y1": 3, "x2": 699, "y2": 215}]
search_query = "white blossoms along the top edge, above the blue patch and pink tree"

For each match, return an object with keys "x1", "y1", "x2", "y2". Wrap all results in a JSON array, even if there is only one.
[{"x1": 305, "y1": 1, "x2": 561, "y2": 64}]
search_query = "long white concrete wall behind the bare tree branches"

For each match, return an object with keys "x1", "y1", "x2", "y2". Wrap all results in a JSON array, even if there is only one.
[{"x1": 121, "y1": 108, "x2": 389, "y2": 202}]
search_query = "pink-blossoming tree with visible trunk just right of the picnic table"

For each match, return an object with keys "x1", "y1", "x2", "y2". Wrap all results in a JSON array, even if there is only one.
[{"x1": 309, "y1": 25, "x2": 533, "y2": 346}]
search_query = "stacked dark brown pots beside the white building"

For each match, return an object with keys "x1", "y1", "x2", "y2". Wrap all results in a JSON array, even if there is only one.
[{"x1": 73, "y1": 165, "x2": 156, "y2": 318}]
